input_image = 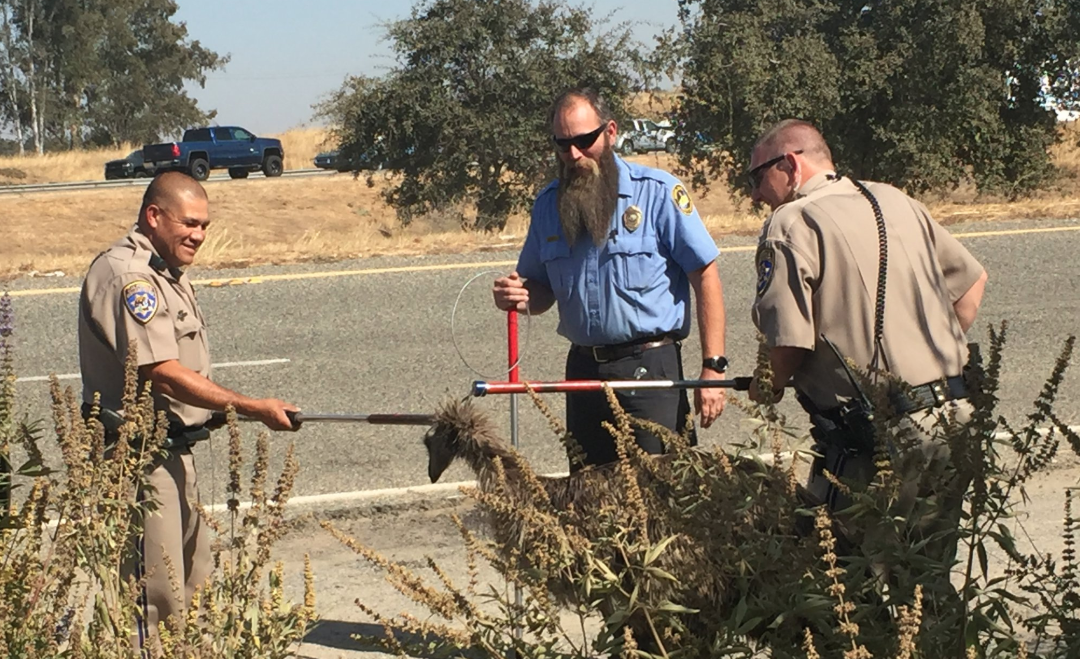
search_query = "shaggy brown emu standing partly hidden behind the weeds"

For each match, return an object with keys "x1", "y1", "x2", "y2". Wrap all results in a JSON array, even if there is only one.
[{"x1": 424, "y1": 395, "x2": 810, "y2": 638}]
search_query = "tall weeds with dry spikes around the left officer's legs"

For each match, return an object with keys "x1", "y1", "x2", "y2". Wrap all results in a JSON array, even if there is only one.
[{"x1": 0, "y1": 295, "x2": 315, "y2": 659}]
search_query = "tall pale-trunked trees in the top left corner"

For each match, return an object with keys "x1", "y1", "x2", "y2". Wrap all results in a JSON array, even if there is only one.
[{"x1": 0, "y1": 0, "x2": 228, "y2": 152}]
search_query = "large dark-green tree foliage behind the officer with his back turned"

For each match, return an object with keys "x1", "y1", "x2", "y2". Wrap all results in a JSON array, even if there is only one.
[{"x1": 676, "y1": 0, "x2": 1080, "y2": 196}]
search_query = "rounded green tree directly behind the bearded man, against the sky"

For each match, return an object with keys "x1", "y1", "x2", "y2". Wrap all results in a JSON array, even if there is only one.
[{"x1": 316, "y1": 0, "x2": 646, "y2": 229}]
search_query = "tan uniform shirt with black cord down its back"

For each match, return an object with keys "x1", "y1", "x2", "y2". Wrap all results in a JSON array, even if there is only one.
[{"x1": 753, "y1": 173, "x2": 983, "y2": 409}]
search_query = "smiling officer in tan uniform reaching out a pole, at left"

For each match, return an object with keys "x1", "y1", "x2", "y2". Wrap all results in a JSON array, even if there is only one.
[{"x1": 79, "y1": 172, "x2": 298, "y2": 646}]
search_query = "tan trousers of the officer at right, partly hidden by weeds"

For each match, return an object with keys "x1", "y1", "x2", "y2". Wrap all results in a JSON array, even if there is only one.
[{"x1": 807, "y1": 400, "x2": 973, "y2": 582}]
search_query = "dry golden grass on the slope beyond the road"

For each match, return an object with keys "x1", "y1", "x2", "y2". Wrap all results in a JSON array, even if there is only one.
[{"x1": 0, "y1": 126, "x2": 1080, "y2": 278}]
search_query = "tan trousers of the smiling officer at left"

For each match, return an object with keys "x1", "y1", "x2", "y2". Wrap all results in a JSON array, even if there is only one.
[{"x1": 121, "y1": 448, "x2": 213, "y2": 651}]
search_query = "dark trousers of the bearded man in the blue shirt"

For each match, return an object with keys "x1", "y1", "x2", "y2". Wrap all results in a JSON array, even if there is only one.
[{"x1": 566, "y1": 342, "x2": 697, "y2": 471}]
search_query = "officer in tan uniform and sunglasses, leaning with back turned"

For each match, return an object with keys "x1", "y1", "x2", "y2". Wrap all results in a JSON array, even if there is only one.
[{"x1": 750, "y1": 120, "x2": 986, "y2": 592}]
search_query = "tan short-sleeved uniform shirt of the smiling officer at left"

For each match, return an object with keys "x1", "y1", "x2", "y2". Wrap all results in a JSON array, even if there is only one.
[{"x1": 79, "y1": 228, "x2": 211, "y2": 426}]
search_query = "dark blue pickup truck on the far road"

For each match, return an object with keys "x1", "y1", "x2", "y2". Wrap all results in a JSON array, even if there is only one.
[{"x1": 143, "y1": 126, "x2": 285, "y2": 180}]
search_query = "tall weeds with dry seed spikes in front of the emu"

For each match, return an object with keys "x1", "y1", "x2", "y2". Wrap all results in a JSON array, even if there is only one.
[{"x1": 324, "y1": 325, "x2": 1080, "y2": 659}]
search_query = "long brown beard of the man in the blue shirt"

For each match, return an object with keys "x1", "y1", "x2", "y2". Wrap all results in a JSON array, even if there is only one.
[{"x1": 556, "y1": 144, "x2": 619, "y2": 247}]
